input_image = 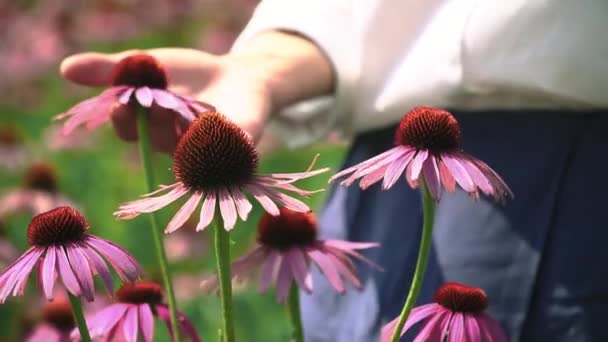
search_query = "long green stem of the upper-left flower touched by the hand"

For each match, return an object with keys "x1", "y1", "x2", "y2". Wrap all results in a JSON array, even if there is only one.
[{"x1": 137, "y1": 107, "x2": 180, "y2": 342}]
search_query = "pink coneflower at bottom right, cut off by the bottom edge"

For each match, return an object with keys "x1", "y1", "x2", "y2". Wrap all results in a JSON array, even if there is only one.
[{"x1": 381, "y1": 282, "x2": 507, "y2": 342}]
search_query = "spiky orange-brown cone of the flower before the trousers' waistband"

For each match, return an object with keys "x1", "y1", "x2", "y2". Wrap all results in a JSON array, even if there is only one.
[{"x1": 395, "y1": 107, "x2": 460, "y2": 154}]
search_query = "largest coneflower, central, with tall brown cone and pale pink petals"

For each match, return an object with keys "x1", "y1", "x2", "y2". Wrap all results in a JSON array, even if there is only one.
[{"x1": 114, "y1": 113, "x2": 328, "y2": 233}]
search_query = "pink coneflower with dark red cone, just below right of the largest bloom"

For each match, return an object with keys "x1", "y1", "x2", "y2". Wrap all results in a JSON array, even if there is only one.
[{"x1": 201, "y1": 208, "x2": 378, "y2": 302}]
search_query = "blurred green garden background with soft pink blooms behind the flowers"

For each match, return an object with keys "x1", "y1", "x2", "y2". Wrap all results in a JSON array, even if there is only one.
[{"x1": 0, "y1": 0, "x2": 344, "y2": 341}]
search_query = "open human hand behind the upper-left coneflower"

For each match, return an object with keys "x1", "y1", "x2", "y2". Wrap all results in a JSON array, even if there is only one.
[{"x1": 61, "y1": 48, "x2": 272, "y2": 153}]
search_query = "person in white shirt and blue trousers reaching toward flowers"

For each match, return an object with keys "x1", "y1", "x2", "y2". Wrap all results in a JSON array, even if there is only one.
[{"x1": 61, "y1": 0, "x2": 608, "y2": 342}]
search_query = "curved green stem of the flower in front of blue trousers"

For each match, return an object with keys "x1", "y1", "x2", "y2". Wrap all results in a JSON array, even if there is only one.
[{"x1": 391, "y1": 180, "x2": 435, "y2": 342}]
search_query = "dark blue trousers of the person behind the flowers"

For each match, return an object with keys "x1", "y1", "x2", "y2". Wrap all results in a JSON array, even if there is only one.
[{"x1": 301, "y1": 110, "x2": 608, "y2": 342}]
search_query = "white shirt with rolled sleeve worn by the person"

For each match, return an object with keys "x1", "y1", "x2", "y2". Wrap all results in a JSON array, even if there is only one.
[{"x1": 233, "y1": 0, "x2": 608, "y2": 146}]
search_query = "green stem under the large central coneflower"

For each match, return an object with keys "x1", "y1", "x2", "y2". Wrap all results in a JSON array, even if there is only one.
[{"x1": 214, "y1": 213, "x2": 234, "y2": 342}]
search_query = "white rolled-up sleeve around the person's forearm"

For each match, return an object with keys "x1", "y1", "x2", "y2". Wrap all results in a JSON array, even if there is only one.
[{"x1": 232, "y1": 0, "x2": 360, "y2": 147}]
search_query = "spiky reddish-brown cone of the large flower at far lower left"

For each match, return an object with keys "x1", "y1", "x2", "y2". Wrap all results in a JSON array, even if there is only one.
[{"x1": 27, "y1": 207, "x2": 89, "y2": 247}]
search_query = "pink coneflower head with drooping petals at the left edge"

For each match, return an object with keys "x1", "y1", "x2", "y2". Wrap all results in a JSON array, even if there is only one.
[{"x1": 0, "y1": 207, "x2": 142, "y2": 303}]
